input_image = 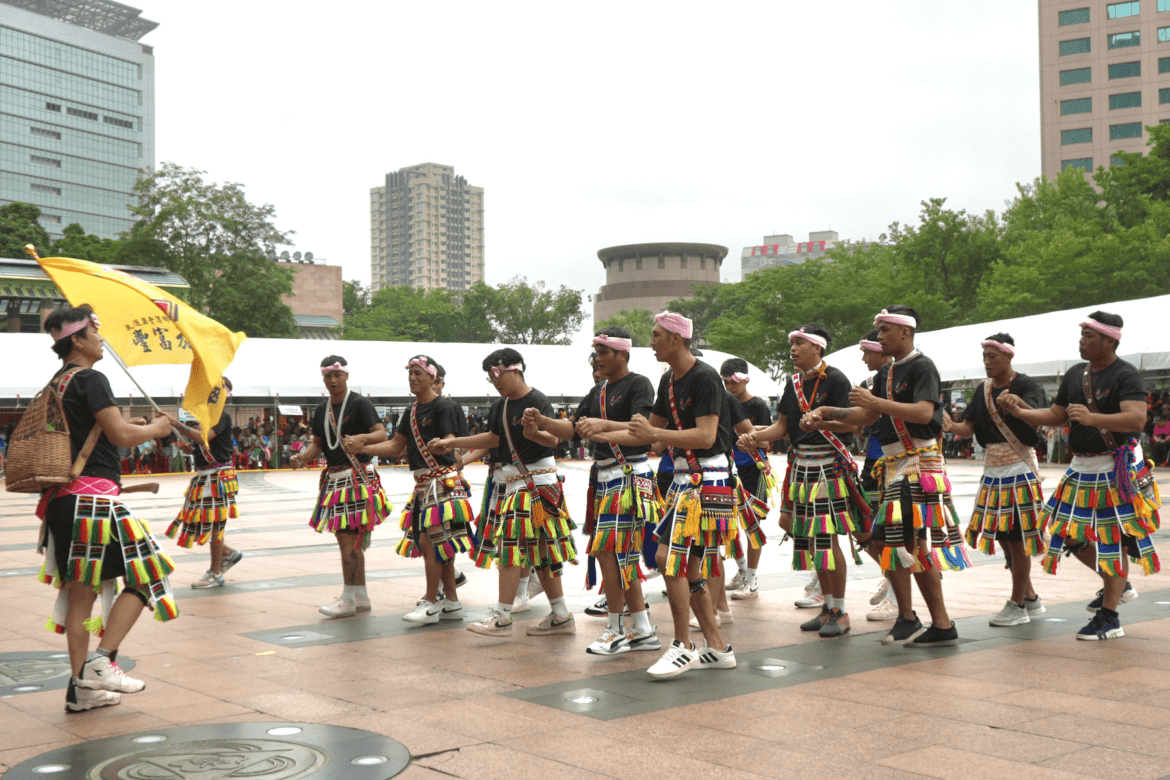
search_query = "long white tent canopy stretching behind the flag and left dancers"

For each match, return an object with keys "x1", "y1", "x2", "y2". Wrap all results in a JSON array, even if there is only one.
[{"x1": 0, "y1": 333, "x2": 782, "y2": 406}]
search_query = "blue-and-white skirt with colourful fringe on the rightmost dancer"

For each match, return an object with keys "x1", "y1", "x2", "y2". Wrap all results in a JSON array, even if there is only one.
[{"x1": 1041, "y1": 440, "x2": 1162, "y2": 577}]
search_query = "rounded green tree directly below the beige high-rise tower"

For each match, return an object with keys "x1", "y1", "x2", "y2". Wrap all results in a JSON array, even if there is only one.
[{"x1": 342, "y1": 281, "x2": 490, "y2": 341}]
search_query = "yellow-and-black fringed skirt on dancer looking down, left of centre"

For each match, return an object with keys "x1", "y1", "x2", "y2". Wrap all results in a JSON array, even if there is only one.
[{"x1": 494, "y1": 457, "x2": 577, "y2": 577}]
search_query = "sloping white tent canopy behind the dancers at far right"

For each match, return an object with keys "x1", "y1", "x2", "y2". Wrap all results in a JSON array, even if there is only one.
[{"x1": 825, "y1": 295, "x2": 1170, "y2": 384}]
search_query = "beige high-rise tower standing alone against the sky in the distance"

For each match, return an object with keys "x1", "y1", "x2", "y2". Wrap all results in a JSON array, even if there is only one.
[{"x1": 370, "y1": 163, "x2": 483, "y2": 295}]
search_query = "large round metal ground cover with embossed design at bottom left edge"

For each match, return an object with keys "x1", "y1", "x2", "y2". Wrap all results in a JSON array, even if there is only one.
[{"x1": 5, "y1": 716, "x2": 411, "y2": 780}]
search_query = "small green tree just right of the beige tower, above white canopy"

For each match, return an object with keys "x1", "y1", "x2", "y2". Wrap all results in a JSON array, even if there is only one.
[{"x1": 463, "y1": 276, "x2": 585, "y2": 344}]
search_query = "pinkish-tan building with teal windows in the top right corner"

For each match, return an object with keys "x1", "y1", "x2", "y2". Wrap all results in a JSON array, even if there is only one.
[{"x1": 1039, "y1": 0, "x2": 1170, "y2": 179}]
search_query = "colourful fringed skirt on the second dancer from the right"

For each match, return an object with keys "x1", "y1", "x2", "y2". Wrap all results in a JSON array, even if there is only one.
[{"x1": 965, "y1": 442, "x2": 1047, "y2": 555}]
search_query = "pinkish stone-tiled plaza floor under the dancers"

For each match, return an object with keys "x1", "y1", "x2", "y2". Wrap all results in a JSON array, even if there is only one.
[{"x1": 0, "y1": 457, "x2": 1170, "y2": 780}]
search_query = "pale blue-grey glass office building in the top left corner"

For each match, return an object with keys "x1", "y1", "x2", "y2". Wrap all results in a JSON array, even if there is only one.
[{"x1": 0, "y1": 0, "x2": 158, "y2": 239}]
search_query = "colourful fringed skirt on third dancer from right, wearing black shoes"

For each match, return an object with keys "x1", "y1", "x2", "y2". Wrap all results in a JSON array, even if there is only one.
[{"x1": 874, "y1": 439, "x2": 971, "y2": 572}]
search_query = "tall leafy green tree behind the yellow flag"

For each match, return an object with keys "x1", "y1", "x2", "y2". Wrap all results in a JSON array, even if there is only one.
[{"x1": 119, "y1": 163, "x2": 297, "y2": 338}]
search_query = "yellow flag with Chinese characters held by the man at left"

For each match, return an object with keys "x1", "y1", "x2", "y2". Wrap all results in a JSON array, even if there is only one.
[{"x1": 37, "y1": 257, "x2": 248, "y2": 441}]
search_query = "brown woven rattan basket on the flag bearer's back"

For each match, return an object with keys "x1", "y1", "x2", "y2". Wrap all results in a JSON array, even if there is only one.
[{"x1": 5, "y1": 385, "x2": 73, "y2": 493}]
